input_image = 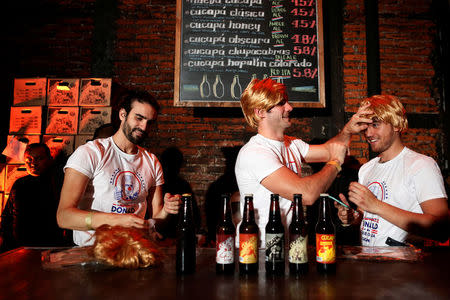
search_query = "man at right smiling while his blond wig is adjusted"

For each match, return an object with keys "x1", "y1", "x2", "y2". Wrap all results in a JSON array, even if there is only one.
[{"x1": 337, "y1": 95, "x2": 448, "y2": 246}]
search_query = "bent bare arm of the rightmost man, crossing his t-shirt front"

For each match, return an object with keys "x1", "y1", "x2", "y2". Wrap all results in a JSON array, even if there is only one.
[{"x1": 349, "y1": 182, "x2": 448, "y2": 240}]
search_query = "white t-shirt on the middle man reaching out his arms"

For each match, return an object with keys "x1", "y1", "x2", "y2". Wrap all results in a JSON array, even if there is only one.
[{"x1": 235, "y1": 134, "x2": 309, "y2": 247}]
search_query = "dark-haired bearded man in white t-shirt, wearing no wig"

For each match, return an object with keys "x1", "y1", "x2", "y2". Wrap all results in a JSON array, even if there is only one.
[{"x1": 57, "y1": 92, "x2": 180, "y2": 246}]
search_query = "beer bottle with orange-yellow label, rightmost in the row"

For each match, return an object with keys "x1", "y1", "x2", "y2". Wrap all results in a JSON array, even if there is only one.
[{"x1": 316, "y1": 194, "x2": 336, "y2": 273}]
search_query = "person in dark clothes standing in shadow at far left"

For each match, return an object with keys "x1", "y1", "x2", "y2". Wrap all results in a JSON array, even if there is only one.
[{"x1": 0, "y1": 143, "x2": 72, "y2": 251}]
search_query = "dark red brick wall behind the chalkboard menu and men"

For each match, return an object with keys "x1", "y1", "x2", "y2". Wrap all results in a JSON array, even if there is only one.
[{"x1": 0, "y1": 0, "x2": 442, "y2": 231}]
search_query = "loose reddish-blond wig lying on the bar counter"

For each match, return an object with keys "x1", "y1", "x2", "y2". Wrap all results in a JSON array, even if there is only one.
[{"x1": 92, "y1": 225, "x2": 161, "y2": 269}]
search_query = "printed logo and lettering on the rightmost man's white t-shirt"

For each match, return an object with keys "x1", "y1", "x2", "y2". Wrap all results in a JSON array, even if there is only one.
[{"x1": 361, "y1": 181, "x2": 389, "y2": 243}]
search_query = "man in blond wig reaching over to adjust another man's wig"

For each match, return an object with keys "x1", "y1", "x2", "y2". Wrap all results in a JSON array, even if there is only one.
[{"x1": 235, "y1": 78, "x2": 371, "y2": 247}]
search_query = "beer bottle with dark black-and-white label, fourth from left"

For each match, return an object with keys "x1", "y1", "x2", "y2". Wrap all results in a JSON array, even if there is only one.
[{"x1": 265, "y1": 194, "x2": 285, "y2": 274}]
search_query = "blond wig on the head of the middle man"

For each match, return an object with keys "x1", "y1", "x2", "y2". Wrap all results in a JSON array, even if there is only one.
[{"x1": 241, "y1": 78, "x2": 287, "y2": 128}]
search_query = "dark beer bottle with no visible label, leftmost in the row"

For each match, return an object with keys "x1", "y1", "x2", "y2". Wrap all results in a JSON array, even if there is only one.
[{"x1": 176, "y1": 194, "x2": 197, "y2": 274}]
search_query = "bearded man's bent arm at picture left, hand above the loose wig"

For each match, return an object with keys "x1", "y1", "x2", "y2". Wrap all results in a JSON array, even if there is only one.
[{"x1": 56, "y1": 168, "x2": 147, "y2": 230}]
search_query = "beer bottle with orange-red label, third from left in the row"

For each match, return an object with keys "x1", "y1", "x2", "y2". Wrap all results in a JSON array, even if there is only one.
[{"x1": 239, "y1": 194, "x2": 259, "y2": 274}]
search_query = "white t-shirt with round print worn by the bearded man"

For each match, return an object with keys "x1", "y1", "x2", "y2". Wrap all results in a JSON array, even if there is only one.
[{"x1": 64, "y1": 137, "x2": 164, "y2": 246}]
